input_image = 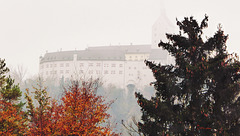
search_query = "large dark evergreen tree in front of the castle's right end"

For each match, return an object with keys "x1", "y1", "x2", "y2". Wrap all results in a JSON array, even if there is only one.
[{"x1": 136, "y1": 16, "x2": 240, "y2": 136}]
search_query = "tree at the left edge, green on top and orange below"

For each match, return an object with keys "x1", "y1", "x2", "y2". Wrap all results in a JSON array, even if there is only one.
[{"x1": 0, "y1": 59, "x2": 26, "y2": 135}]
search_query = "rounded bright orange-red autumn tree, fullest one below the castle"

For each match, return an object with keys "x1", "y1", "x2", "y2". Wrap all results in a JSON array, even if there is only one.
[{"x1": 59, "y1": 82, "x2": 114, "y2": 136}]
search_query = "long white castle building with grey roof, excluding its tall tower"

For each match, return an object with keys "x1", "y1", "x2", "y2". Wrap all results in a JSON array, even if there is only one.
[{"x1": 39, "y1": 45, "x2": 172, "y2": 88}]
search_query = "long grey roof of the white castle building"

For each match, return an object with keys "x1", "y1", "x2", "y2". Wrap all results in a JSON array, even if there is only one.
[{"x1": 40, "y1": 45, "x2": 166, "y2": 63}]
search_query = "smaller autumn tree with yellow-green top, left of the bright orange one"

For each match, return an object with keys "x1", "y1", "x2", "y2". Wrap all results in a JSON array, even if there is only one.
[{"x1": 25, "y1": 78, "x2": 61, "y2": 136}]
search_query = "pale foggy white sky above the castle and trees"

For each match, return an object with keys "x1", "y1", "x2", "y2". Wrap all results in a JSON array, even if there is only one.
[{"x1": 0, "y1": 0, "x2": 240, "y2": 76}]
